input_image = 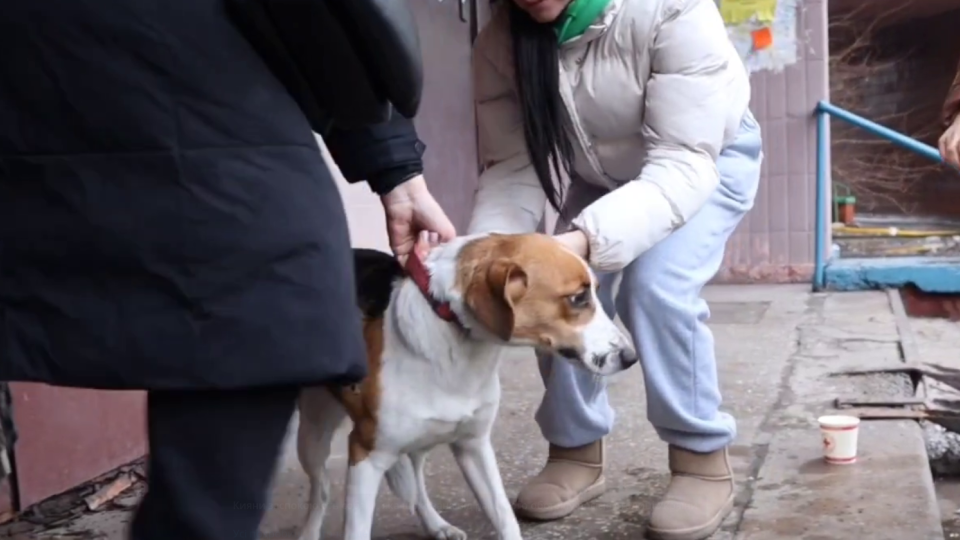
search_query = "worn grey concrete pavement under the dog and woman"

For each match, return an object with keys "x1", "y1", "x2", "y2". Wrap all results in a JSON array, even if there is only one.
[{"x1": 11, "y1": 285, "x2": 948, "y2": 540}]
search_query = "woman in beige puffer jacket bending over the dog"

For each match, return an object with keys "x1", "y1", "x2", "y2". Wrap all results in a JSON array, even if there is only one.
[{"x1": 469, "y1": 0, "x2": 762, "y2": 540}]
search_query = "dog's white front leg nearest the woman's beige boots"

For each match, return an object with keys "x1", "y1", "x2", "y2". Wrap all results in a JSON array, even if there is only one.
[{"x1": 452, "y1": 435, "x2": 523, "y2": 540}]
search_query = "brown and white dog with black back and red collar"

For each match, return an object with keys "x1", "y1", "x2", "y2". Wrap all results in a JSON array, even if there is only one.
[{"x1": 297, "y1": 234, "x2": 637, "y2": 540}]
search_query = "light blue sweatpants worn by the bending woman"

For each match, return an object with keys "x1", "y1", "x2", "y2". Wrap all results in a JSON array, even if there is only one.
[{"x1": 537, "y1": 113, "x2": 762, "y2": 452}]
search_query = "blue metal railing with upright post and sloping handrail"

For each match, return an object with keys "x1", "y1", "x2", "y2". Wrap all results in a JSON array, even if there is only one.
[{"x1": 813, "y1": 101, "x2": 943, "y2": 291}]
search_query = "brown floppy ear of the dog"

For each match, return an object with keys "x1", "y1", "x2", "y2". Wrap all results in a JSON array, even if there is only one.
[{"x1": 465, "y1": 259, "x2": 527, "y2": 341}]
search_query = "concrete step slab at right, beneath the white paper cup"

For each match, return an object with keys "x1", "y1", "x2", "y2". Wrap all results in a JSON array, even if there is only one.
[{"x1": 735, "y1": 292, "x2": 944, "y2": 540}]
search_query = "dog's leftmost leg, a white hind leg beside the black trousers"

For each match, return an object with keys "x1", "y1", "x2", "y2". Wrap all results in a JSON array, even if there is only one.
[{"x1": 297, "y1": 388, "x2": 346, "y2": 540}]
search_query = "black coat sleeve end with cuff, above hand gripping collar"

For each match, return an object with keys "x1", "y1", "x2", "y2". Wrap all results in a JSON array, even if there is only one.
[{"x1": 323, "y1": 113, "x2": 426, "y2": 195}]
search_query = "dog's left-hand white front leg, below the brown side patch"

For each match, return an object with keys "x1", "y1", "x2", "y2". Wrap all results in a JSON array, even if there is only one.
[{"x1": 343, "y1": 452, "x2": 397, "y2": 540}]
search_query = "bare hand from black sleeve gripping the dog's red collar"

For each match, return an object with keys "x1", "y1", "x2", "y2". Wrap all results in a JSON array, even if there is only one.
[{"x1": 380, "y1": 175, "x2": 457, "y2": 263}]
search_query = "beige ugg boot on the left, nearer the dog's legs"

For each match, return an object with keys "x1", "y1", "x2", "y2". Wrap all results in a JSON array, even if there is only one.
[{"x1": 515, "y1": 439, "x2": 606, "y2": 521}]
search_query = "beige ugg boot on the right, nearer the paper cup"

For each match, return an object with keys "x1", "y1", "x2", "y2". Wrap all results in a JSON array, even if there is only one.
[{"x1": 647, "y1": 446, "x2": 734, "y2": 540}]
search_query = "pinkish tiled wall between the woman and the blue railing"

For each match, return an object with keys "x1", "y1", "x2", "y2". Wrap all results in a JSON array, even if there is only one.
[{"x1": 717, "y1": 0, "x2": 829, "y2": 283}]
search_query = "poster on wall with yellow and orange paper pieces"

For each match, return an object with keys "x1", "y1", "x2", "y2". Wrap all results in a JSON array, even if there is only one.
[{"x1": 717, "y1": 0, "x2": 801, "y2": 73}]
